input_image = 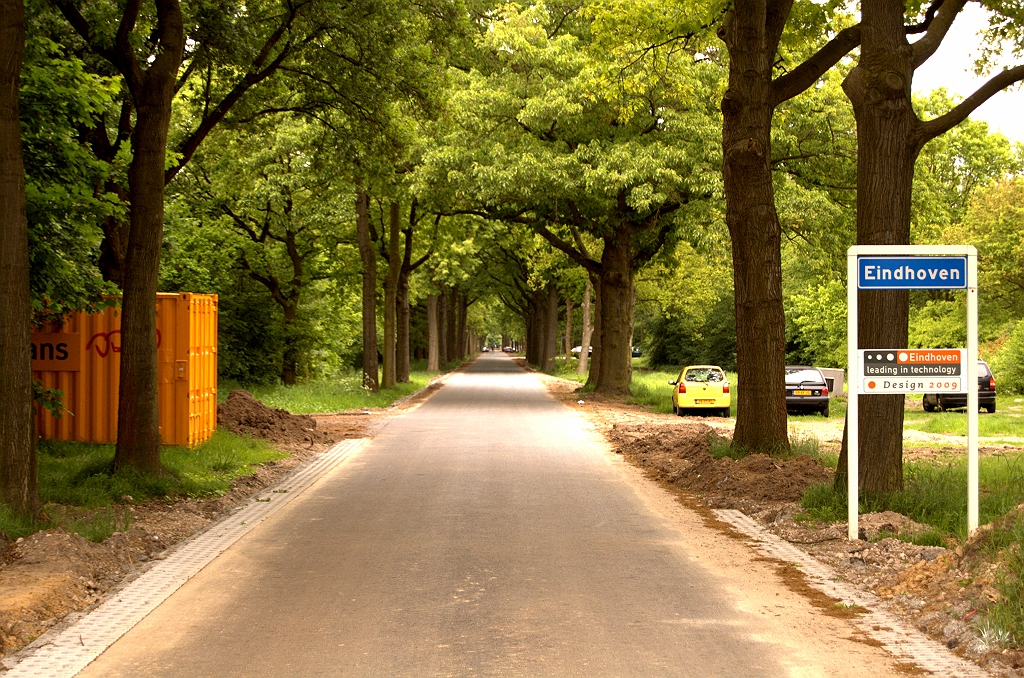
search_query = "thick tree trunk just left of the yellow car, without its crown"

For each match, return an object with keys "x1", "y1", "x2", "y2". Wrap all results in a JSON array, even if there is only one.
[{"x1": 592, "y1": 235, "x2": 633, "y2": 397}]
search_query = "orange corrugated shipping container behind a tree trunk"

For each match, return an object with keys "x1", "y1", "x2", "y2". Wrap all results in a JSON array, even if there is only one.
[{"x1": 32, "y1": 293, "x2": 217, "y2": 448}]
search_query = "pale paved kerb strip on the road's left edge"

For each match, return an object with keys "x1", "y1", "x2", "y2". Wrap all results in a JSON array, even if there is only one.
[{"x1": 2, "y1": 438, "x2": 367, "y2": 678}]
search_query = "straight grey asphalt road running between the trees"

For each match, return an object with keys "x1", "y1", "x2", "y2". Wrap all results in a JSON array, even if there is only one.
[{"x1": 80, "y1": 355, "x2": 891, "y2": 678}]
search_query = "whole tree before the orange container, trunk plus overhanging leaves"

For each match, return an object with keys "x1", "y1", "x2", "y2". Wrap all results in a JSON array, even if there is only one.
[{"x1": 52, "y1": 0, "x2": 454, "y2": 472}]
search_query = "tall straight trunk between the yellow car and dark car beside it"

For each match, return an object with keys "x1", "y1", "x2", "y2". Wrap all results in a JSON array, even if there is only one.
[{"x1": 722, "y1": 2, "x2": 790, "y2": 453}]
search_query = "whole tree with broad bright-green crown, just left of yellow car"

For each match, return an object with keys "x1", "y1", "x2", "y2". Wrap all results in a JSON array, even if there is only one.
[{"x1": 423, "y1": 4, "x2": 715, "y2": 395}]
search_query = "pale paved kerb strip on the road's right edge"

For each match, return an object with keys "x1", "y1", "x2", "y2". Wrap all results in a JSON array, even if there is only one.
[{"x1": 715, "y1": 509, "x2": 991, "y2": 678}]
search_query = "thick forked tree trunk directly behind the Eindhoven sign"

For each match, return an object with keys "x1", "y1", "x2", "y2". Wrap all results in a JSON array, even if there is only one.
[{"x1": 837, "y1": 0, "x2": 1024, "y2": 492}]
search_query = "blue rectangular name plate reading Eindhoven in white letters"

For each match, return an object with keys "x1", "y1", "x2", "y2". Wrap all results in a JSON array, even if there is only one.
[{"x1": 857, "y1": 256, "x2": 967, "y2": 290}]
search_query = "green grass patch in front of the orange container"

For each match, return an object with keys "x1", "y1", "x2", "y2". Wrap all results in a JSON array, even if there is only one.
[{"x1": 0, "y1": 431, "x2": 287, "y2": 542}]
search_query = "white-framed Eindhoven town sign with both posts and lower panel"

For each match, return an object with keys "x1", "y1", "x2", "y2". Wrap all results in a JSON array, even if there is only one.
[{"x1": 846, "y1": 245, "x2": 978, "y2": 540}]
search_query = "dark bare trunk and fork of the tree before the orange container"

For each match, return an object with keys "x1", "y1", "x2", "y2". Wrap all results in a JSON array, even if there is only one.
[{"x1": 55, "y1": 0, "x2": 185, "y2": 473}]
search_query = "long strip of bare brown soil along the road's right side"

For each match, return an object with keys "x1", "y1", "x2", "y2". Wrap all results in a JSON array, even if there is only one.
[{"x1": 536, "y1": 373, "x2": 1024, "y2": 676}]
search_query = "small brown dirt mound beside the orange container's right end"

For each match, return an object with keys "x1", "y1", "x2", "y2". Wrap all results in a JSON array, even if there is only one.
[{"x1": 217, "y1": 389, "x2": 335, "y2": 448}]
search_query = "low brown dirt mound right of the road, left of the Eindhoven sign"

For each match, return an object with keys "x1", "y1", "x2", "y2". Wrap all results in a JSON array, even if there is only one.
[{"x1": 608, "y1": 424, "x2": 833, "y2": 502}]
